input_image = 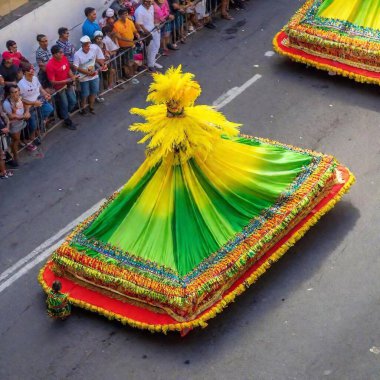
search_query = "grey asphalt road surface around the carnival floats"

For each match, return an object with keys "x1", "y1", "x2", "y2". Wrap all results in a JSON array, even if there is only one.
[{"x1": 0, "y1": 0, "x2": 380, "y2": 380}]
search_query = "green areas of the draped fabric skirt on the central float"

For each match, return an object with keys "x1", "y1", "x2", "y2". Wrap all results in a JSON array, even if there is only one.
[{"x1": 75, "y1": 138, "x2": 311, "y2": 275}]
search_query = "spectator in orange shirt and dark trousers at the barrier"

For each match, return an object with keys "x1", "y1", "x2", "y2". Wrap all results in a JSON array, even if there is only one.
[{"x1": 113, "y1": 9, "x2": 140, "y2": 79}]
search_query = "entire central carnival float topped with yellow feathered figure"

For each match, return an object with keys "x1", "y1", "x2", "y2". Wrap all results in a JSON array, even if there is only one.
[{"x1": 39, "y1": 66, "x2": 354, "y2": 335}]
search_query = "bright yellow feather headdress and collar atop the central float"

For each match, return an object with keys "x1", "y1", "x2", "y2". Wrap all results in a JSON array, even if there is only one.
[{"x1": 130, "y1": 66, "x2": 240, "y2": 166}]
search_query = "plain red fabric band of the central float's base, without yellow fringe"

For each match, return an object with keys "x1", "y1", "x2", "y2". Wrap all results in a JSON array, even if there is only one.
[{"x1": 42, "y1": 167, "x2": 350, "y2": 326}]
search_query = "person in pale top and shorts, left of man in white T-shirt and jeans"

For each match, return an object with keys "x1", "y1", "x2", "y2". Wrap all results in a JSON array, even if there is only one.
[{"x1": 3, "y1": 84, "x2": 30, "y2": 167}]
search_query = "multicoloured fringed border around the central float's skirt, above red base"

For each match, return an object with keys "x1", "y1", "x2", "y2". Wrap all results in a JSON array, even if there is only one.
[{"x1": 44, "y1": 136, "x2": 344, "y2": 322}]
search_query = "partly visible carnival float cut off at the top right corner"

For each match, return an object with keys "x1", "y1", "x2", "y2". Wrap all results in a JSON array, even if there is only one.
[{"x1": 273, "y1": 0, "x2": 380, "y2": 84}]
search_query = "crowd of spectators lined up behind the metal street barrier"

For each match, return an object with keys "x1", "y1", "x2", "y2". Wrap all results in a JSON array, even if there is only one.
[{"x1": 0, "y1": 0, "x2": 243, "y2": 179}]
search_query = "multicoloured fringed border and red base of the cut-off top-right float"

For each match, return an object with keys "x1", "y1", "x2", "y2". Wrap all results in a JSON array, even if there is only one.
[{"x1": 273, "y1": 0, "x2": 380, "y2": 84}]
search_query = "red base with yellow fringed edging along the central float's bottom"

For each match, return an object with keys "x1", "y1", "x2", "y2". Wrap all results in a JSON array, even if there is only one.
[{"x1": 38, "y1": 167, "x2": 355, "y2": 334}]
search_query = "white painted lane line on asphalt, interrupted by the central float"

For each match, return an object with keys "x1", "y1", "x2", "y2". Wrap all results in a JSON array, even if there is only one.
[{"x1": 0, "y1": 74, "x2": 261, "y2": 293}]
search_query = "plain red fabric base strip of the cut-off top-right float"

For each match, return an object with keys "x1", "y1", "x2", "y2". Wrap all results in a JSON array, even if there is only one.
[{"x1": 276, "y1": 31, "x2": 380, "y2": 81}]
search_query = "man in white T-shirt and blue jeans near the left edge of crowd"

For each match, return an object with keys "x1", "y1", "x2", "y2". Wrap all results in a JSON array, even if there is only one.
[{"x1": 18, "y1": 65, "x2": 54, "y2": 145}]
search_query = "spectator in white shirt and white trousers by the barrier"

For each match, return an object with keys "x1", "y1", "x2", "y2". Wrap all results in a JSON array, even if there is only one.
[{"x1": 135, "y1": 0, "x2": 162, "y2": 72}]
